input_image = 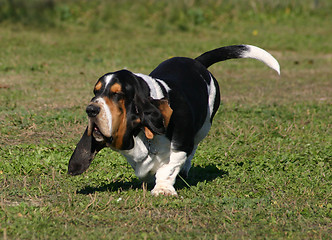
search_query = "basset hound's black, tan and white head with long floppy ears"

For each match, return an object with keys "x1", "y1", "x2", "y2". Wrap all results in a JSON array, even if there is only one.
[{"x1": 68, "y1": 70, "x2": 172, "y2": 175}]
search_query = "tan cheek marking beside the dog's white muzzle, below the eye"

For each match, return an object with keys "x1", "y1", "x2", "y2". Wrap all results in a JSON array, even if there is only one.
[{"x1": 104, "y1": 96, "x2": 127, "y2": 149}]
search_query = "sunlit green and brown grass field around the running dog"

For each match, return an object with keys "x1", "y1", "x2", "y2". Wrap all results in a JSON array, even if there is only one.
[{"x1": 0, "y1": 0, "x2": 332, "y2": 239}]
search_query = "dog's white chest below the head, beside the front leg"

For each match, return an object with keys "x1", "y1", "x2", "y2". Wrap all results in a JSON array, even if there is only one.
[{"x1": 120, "y1": 132, "x2": 171, "y2": 179}]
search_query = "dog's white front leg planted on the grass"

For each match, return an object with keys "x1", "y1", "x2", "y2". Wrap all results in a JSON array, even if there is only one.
[{"x1": 151, "y1": 150, "x2": 187, "y2": 196}]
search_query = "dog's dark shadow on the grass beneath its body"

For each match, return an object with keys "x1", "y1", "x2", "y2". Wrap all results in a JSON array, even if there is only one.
[{"x1": 77, "y1": 165, "x2": 227, "y2": 195}]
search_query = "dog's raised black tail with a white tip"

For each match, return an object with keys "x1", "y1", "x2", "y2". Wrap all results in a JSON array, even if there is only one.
[{"x1": 196, "y1": 45, "x2": 280, "y2": 75}]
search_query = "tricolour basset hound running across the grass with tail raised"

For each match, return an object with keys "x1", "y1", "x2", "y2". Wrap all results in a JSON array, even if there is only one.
[{"x1": 68, "y1": 45, "x2": 280, "y2": 196}]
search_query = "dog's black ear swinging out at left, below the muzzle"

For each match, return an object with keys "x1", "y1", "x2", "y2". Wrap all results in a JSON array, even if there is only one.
[{"x1": 68, "y1": 128, "x2": 106, "y2": 175}]
